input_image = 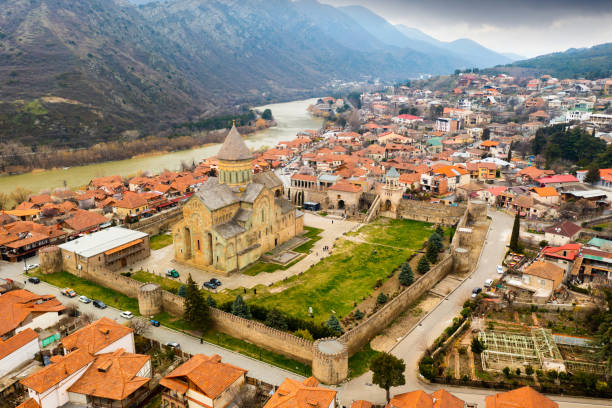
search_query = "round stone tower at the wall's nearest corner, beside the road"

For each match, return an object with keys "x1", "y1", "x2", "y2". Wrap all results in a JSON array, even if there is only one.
[{"x1": 312, "y1": 338, "x2": 348, "y2": 384}]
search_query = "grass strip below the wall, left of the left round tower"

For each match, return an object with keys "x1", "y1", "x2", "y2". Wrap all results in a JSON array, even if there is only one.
[{"x1": 30, "y1": 271, "x2": 138, "y2": 315}]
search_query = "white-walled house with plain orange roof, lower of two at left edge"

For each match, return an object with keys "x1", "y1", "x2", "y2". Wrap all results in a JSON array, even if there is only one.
[{"x1": 0, "y1": 328, "x2": 40, "y2": 377}]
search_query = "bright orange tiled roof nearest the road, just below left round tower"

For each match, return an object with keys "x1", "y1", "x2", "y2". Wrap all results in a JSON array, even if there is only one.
[{"x1": 62, "y1": 317, "x2": 133, "y2": 354}]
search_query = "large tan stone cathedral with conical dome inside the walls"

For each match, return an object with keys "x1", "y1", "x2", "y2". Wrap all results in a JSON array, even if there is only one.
[{"x1": 172, "y1": 126, "x2": 304, "y2": 275}]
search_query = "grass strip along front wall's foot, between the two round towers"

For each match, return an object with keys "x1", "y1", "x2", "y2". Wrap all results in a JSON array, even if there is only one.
[{"x1": 155, "y1": 312, "x2": 312, "y2": 377}]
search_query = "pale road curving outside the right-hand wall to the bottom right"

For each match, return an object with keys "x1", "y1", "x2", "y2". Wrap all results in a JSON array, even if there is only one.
[{"x1": 339, "y1": 211, "x2": 612, "y2": 408}]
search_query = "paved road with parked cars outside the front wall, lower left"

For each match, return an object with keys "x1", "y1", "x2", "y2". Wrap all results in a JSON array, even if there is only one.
[{"x1": 0, "y1": 258, "x2": 303, "y2": 385}]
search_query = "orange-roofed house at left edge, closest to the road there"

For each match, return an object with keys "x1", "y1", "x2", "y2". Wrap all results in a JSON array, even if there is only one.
[{"x1": 0, "y1": 289, "x2": 66, "y2": 339}]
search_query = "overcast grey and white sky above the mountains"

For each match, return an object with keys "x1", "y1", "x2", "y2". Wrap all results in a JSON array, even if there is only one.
[{"x1": 320, "y1": 0, "x2": 612, "y2": 57}]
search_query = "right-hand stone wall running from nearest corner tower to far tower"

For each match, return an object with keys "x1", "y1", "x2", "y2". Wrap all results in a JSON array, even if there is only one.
[{"x1": 340, "y1": 255, "x2": 453, "y2": 355}]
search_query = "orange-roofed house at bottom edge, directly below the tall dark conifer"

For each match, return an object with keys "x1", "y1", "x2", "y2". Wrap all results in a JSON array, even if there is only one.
[{"x1": 159, "y1": 354, "x2": 247, "y2": 408}]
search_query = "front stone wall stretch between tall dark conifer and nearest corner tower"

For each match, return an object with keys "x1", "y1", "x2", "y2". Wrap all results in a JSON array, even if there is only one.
[{"x1": 210, "y1": 309, "x2": 313, "y2": 364}]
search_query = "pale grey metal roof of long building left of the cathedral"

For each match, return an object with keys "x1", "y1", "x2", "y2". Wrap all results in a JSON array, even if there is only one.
[{"x1": 59, "y1": 227, "x2": 149, "y2": 258}]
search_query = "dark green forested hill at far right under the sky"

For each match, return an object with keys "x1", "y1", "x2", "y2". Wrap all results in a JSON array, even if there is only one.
[{"x1": 494, "y1": 43, "x2": 612, "y2": 79}]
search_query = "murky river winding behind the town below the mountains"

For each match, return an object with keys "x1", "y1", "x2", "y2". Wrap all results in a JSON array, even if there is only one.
[{"x1": 0, "y1": 99, "x2": 322, "y2": 193}]
